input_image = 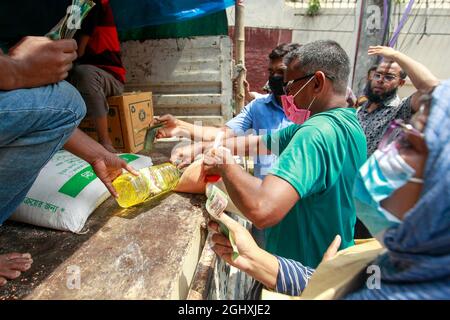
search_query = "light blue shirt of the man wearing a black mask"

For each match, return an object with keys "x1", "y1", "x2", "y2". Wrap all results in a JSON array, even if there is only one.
[{"x1": 226, "y1": 94, "x2": 293, "y2": 179}]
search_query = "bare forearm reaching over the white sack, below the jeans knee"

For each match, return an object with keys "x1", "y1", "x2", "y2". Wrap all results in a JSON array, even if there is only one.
[{"x1": 64, "y1": 128, "x2": 108, "y2": 164}]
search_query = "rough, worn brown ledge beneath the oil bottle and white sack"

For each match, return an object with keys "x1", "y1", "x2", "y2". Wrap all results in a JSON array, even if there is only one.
[{"x1": 0, "y1": 144, "x2": 207, "y2": 299}]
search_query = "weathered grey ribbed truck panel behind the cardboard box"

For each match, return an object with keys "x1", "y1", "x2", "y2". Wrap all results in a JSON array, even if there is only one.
[{"x1": 122, "y1": 36, "x2": 232, "y2": 126}]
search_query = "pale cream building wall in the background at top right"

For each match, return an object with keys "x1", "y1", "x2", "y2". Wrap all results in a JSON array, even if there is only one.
[{"x1": 227, "y1": 0, "x2": 450, "y2": 96}]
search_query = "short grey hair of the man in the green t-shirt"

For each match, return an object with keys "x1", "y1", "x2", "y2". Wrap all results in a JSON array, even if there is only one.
[{"x1": 284, "y1": 40, "x2": 350, "y2": 94}]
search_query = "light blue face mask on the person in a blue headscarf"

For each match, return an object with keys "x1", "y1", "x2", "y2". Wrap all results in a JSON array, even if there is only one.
[{"x1": 353, "y1": 144, "x2": 415, "y2": 236}]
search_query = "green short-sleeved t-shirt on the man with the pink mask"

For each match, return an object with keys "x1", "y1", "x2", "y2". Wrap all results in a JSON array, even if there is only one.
[{"x1": 263, "y1": 108, "x2": 367, "y2": 268}]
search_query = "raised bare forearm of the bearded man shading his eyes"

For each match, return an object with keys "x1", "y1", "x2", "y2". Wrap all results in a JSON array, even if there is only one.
[{"x1": 394, "y1": 51, "x2": 439, "y2": 92}]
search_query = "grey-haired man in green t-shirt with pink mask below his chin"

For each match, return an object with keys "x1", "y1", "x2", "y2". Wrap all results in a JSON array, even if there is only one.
[{"x1": 204, "y1": 41, "x2": 367, "y2": 267}]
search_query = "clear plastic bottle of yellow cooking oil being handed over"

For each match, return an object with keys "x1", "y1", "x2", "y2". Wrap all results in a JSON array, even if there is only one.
[{"x1": 112, "y1": 163, "x2": 180, "y2": 208}]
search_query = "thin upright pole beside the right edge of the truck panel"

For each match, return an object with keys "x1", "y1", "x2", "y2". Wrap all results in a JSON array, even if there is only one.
[{"x1": 234, "y1": 0, "x2": 246, "y2": 114}]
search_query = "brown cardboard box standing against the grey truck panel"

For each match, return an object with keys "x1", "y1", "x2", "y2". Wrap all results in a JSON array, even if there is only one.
[{"x1": 79, "y1": 92, "x2": 153, "y2": 153}]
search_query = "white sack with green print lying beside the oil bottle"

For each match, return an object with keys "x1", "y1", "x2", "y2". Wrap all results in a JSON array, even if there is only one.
[{"x1": 11, "y1": 150, "x2": 152, "y2": 233}]
